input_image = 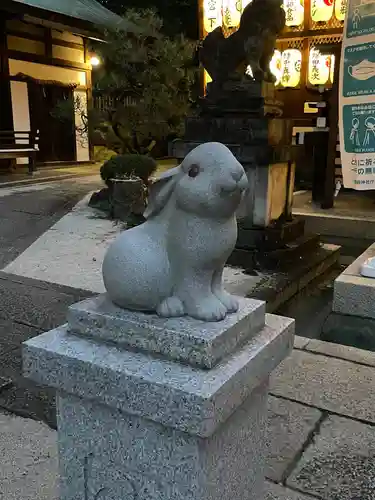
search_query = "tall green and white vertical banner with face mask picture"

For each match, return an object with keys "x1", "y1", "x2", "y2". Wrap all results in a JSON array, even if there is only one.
[{"x1": 339, "y1": 0, "x2": 375, "y2": 190}]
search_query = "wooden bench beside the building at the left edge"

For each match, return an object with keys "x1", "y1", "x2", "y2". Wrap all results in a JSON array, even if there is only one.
[{"x1": 0, "y1": 130, "x2": 39, "y2": 174}]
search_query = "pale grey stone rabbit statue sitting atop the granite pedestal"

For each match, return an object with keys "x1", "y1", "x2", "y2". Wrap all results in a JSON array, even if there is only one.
[{"x1": 103, "y1": 143, "x2": 248, "y2": 321}]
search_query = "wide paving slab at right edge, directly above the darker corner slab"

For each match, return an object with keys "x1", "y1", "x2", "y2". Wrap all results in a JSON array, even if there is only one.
[{"x1": 270, "y1": 350, "x2": 375, "y2": 423}]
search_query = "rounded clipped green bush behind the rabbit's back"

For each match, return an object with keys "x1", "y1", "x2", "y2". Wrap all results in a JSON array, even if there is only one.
[{"x1": 100, "y1": 154, "x2": 157, "y2": 185}]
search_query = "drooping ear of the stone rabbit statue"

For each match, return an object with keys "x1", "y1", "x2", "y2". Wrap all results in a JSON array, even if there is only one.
[{"x1": 143, "y1": 165, "x2": 183, "y2": 219}]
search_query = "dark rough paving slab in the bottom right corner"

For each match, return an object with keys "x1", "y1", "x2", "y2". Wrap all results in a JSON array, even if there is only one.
[{"x1": 287, "y1": 415, "x2": 375, "y2": 500}]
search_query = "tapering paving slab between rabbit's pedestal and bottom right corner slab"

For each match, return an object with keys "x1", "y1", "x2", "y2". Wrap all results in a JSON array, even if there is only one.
[{"x1": 266, "y1": 396, "x2": 322, "y2": 482}]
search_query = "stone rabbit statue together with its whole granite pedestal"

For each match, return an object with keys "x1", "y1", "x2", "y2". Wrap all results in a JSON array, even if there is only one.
[{"x1": 24, "y1": 144, "x2": 294, "y2": 500}]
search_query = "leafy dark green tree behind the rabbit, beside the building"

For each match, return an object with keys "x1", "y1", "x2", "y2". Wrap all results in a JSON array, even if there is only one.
[{"x1": 94, "y1": 10, "x2": 196, "y2": 154}]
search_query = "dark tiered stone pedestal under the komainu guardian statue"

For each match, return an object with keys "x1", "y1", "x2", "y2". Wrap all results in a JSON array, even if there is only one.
[{"x1": 170, "y1": 80, "x2": 308, "y2": 262}]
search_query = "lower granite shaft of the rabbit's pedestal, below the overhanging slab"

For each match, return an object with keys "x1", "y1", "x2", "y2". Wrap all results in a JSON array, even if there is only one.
[{"x1": 58, "y1": 385, "x2": 267, "y2": 500}]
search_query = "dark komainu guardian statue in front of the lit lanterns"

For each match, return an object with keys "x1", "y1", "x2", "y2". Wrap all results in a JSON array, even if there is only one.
[{"x1": 199, "y1": 0, "x2": 285, "y2": 83}]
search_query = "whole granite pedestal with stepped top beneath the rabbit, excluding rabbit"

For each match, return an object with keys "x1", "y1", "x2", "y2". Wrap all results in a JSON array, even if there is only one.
[{"x1": 24, "y1": 295, "x2": 294, "y2": 500}]
